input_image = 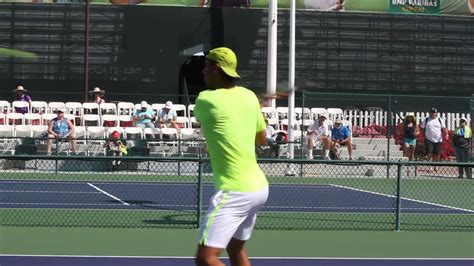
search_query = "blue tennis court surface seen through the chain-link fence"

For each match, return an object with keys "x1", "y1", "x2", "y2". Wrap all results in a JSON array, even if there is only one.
[{"x1": 0, "y1": 180, "x2": 473, "y2": 214}]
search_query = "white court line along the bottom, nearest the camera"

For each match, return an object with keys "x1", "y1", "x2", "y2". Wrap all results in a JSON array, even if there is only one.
[{"x1": 0, "y1": 254, "x2": 468, "y2": 261}]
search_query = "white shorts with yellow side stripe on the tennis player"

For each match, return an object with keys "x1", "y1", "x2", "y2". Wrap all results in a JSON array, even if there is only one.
[{"x1": 199, "y1": 188, "x2": 268, "y2": 249}]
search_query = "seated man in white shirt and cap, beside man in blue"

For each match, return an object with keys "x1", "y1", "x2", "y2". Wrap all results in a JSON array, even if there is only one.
[{"x1": 306, "y1": 114, "x2": 331, "y2": 160}]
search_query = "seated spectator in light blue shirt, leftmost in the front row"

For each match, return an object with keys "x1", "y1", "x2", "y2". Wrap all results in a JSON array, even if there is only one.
[{"x1": 47, "y1": 108, "x2": 76, "y2": 155}]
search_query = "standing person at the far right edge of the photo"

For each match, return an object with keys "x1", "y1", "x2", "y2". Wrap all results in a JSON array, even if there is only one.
[{"x1": 453, "y1": 118, "x2": 472, "y2": 179}]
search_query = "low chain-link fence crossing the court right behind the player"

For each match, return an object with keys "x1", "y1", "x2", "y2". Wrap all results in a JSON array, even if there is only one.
[{"x1": 0, "y1": 155, "x2": 474, "y2": 231}]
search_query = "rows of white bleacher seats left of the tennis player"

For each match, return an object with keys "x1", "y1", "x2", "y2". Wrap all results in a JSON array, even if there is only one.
[{"x1": 0, "y1": 101, "x2": 202, "y2": 156}]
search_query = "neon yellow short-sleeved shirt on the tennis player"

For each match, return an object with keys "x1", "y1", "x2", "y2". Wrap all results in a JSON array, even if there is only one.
[{"x1": 194, "y1": 87, "x2": 268, "y2": 192}]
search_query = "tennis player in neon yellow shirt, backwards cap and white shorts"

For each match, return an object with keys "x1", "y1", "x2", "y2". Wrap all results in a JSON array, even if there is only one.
[{"x1": 194, "y1": 47, "x2": 268, "y2": 266}]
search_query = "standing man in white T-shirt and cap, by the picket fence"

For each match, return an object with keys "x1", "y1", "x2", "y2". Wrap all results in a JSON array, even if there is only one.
[{"x1": 421, "y1": 108, "x2": 448, "y2": 172}]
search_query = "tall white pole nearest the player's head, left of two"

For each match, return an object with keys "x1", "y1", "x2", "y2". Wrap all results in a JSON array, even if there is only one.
[{"x1": 267, "y1": 0, "x2": 278, "y2": 108}]
